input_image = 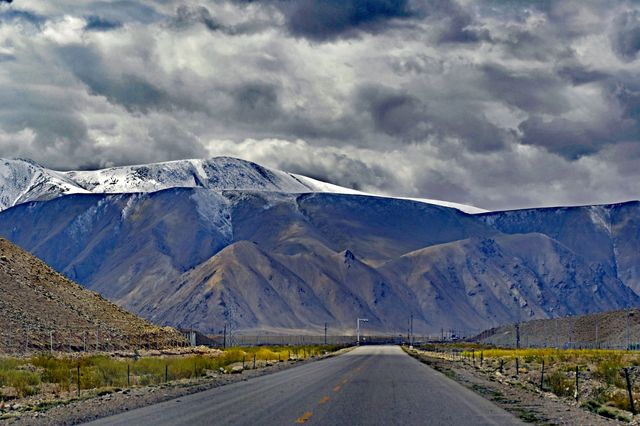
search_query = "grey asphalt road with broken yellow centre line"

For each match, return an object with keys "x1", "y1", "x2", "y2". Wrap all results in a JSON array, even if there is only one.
[{"x1": 85, "y1": 346, "x2": 523, "y2": 426}]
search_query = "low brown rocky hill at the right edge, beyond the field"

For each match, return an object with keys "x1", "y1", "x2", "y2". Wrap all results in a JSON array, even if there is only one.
[{"x1": 472, "y1": 308, "x2": 640, "y2": 350}]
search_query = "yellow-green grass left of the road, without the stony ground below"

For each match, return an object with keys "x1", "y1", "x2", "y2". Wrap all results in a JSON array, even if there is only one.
[{"x1": 0, "y1": 346, "x2": 341, "y2": 402}]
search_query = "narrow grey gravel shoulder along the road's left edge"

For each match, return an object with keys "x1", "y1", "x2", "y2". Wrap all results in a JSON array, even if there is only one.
[{"x1": 0, "y1": 348, "x2": 352, "y2": 426}]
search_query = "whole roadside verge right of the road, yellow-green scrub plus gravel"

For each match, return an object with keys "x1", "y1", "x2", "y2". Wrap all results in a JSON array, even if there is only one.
[{"x1": 405, "y1": 343, "x2": 640, "y2": 424}]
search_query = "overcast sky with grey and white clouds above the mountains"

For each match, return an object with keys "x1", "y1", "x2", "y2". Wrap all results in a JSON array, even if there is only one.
[{"x1": 0, "y1": 0, "x2": 640, "y2": 209}]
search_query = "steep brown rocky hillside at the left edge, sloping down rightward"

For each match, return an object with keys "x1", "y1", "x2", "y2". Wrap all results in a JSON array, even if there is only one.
[{"x1": 0, "y1": 239, "x2": 180, "y2": 353}]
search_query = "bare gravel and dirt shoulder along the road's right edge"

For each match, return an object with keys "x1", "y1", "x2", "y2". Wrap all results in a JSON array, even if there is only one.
[{"x1": 408, "y1": 351, "x2": 638, "y2": 426}]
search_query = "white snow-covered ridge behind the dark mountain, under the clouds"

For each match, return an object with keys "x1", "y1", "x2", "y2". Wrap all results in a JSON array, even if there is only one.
[{"x1": 0, "y1": 157, "x2": 485, "y2": 214}]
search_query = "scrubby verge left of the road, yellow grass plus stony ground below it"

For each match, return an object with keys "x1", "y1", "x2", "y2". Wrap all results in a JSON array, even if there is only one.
[{"x1": 0, "y1": 346, "x2": 350, "y2": 418}]
